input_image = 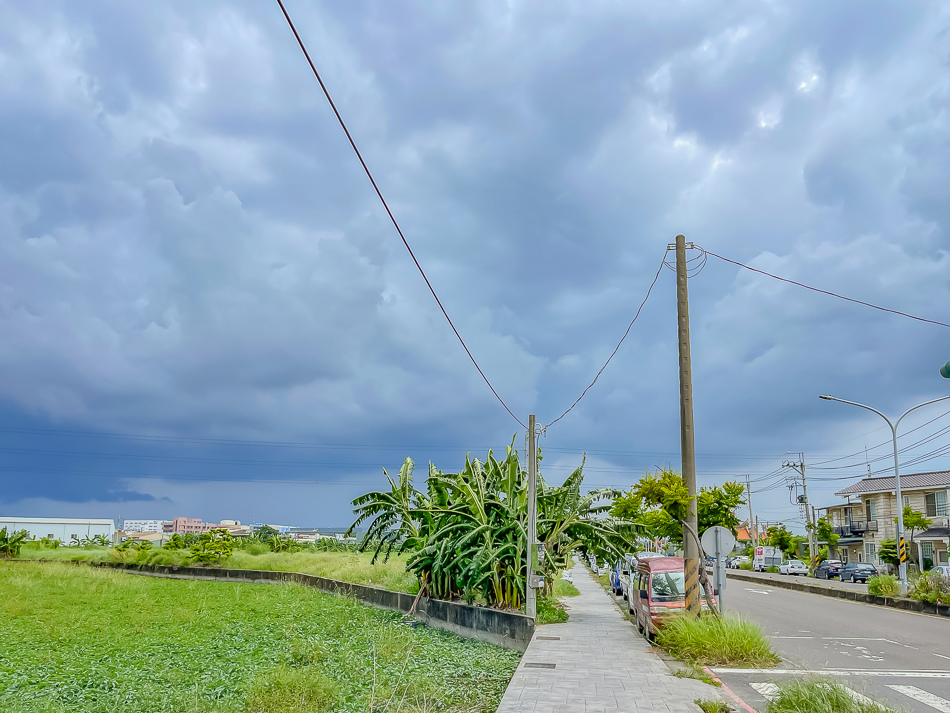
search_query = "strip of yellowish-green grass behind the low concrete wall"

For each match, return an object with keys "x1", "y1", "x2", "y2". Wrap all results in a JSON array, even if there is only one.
[{"x1": 20, "y1": 547, "x2": 419, "y2": 594}]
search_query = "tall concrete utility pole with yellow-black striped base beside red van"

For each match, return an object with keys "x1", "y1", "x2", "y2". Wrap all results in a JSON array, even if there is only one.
[{"x1": 673, "y1": 235, "x2": 700, "y2": 614}]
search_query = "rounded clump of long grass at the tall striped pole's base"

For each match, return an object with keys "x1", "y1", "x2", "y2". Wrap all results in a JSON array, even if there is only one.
[{"x1": 657, "y1": 614, "x2": 780, "y2": 668}]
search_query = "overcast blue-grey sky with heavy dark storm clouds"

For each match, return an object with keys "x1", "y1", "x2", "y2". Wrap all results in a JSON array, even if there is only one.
[{"x1": 0, "y1": 0, "x2": 950, "y2": 526}]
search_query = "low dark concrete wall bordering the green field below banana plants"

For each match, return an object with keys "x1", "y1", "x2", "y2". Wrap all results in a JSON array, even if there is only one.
[{"x1": 87, "y1": 560, "x2": 534, "y2": 651}]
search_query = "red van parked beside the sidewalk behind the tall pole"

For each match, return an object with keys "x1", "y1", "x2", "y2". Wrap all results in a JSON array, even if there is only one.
[{"x1": 627, "y1": 557, "x2": 715, "y2": 638}]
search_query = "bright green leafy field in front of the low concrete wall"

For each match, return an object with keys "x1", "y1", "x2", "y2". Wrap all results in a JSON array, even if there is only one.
[{"x1": 0, "y1": 563, "x2": 519, "y2": 713}]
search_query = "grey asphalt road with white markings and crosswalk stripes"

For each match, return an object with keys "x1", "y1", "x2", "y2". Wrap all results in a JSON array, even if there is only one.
[{"x1": 714, "y1": 575, "x2": 950, "y2": 713}]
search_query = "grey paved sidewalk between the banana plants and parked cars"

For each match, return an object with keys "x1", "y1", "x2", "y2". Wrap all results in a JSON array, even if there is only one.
[{"x1": 497, "y1": 565, "x2": 719, "y2": 713}]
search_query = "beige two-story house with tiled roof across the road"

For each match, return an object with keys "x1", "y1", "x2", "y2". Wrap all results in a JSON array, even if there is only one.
[{"x1": 825, "y1": 470, "x2": 950, "y2": 564}]
